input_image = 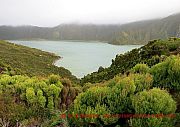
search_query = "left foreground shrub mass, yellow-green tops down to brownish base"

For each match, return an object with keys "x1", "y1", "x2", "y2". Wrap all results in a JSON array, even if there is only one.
[{"x1": 0, "y1": 74, "x2": 79, "y2": 125}]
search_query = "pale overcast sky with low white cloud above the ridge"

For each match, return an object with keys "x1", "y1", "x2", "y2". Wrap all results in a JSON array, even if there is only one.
[{"x1": 0, "y1": 0, "x2": 180, "y2": 26}]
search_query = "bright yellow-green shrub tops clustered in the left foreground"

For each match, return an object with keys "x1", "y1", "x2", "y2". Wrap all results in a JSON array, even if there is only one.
[{"x1": 0, "y1": 75, "x2": 63, "y2": 108}]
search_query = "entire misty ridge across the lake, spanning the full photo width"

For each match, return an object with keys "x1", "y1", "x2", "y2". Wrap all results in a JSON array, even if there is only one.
[{"x1": 0, "y1": 14, "x2": 180, "y2": 44}]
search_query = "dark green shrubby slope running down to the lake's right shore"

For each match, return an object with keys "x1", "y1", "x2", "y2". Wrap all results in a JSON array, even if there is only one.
[{"x1": 81, "y1": 38, "x2": 180, "y2": 84}]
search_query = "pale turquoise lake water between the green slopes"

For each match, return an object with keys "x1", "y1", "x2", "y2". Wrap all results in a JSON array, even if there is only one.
[{"x1": 11, "y1": 41, "x2": 140, "y2": 78}]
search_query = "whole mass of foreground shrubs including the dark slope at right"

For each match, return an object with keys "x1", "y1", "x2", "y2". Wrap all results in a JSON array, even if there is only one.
[{"x1": 0, "y1": 38, "x2": 180, "y2": 127}]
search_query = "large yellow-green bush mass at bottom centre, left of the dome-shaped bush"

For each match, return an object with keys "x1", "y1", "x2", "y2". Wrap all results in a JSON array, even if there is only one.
[{"x1": 70, "y1": 73, "x2": 152, "y2": 126}]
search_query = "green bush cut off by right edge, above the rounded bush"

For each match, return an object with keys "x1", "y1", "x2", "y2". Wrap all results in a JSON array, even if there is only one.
[{"x1": 150, "y1": 56, "x2": 180, "y2": 91}]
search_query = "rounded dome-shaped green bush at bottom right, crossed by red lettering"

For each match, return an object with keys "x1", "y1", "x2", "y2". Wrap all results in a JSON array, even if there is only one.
[{"x1": 130, "y1": 88, "x2": 176, "y2": 127}]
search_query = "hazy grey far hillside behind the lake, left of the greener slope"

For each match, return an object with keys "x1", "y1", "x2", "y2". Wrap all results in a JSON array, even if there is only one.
[{"x1": 0, "y1": 24, "x2": 119, "y2": 41}]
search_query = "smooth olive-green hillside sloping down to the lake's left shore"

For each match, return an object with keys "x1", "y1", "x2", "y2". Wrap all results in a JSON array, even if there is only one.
[{"x1": 0, "y1": 41, "x2": 76, "y2": 81}]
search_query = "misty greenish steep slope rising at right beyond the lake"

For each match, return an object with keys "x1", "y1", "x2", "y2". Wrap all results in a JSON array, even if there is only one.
[{"x1": 112, "y1": 14, "x2": 180, "y2": 44}]
